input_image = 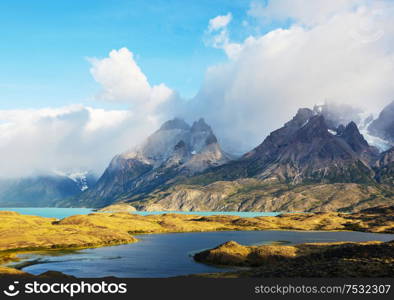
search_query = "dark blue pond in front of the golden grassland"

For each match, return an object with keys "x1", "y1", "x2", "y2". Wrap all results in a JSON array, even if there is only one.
[{"x1": 16, "y1": 231, "x2": 394, "y2": 277}]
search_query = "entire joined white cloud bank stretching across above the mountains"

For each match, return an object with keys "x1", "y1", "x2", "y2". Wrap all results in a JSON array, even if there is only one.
[{"x1": 0, "y1": 0, "x2": 394, "y2": 177}]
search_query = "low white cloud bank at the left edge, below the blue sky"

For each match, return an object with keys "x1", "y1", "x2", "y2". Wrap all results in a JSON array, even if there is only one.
[{"x1": 0, "y1": 105, "x2": 159, "y2": 177}]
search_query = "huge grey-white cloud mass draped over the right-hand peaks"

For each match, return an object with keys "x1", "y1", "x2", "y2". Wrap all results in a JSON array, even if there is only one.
[{"x1": 189, "y1": 0, "x2": 394, "y2": 152}]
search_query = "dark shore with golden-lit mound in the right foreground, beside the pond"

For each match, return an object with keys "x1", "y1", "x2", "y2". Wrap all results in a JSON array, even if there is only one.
[{"x1": 194, "y1": 241, "x2": 394, "y2": 277}]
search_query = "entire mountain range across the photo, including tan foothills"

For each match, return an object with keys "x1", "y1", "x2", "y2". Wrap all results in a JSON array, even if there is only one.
[{"x1": 0, "y1": 102, "x2": 394, "y2": 211}]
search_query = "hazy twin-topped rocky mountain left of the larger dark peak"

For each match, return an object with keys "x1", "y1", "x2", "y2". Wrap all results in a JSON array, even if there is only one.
[{"x1": 74, "y1": 119, "x2": 229, "y2": 206}]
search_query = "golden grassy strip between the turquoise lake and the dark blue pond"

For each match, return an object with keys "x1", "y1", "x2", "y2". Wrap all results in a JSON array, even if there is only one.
[{"x1": 0, "y1": 207, "x2": 394, "y2": 275}]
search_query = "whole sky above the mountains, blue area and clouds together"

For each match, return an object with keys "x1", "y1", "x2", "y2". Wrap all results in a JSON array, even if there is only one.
[{"x1": 0, "y1": 0, "x2": 394, "y2": 177}]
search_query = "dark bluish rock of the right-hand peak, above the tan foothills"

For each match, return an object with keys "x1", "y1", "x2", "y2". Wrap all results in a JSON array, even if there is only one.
[{"x1": 202, "y1": 109, "x2": 374, "y2": 184}]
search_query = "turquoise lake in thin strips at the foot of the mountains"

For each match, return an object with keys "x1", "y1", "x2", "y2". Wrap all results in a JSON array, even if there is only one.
[{"x1": 0, "y1": 207, "x2": 280, "y2": 219}]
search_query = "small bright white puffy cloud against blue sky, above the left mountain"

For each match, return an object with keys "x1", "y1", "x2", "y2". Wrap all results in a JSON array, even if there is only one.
[{"x1": 89, "y1": 48, "x2": 173, "y2": 111}]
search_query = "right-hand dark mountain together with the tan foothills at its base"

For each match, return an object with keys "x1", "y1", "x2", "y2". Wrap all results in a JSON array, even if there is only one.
[{"x1": 123, "y1": 109, "x2": 394, "y2": 211}]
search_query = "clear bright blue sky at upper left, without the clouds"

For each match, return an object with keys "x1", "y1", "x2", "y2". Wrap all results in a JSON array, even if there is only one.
[{"x1": 0, "y1": 0, "x2": 258, "y2": 109}]
